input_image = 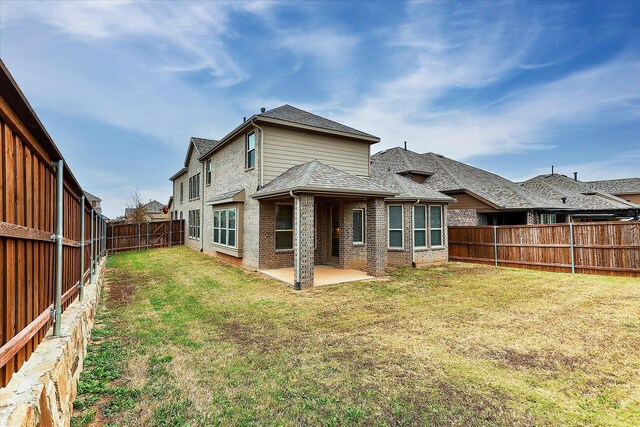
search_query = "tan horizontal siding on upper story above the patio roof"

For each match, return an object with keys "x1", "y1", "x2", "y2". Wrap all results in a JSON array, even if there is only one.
[{"x1": 264, "y1": 126, "x2": 369, "y2": 184}]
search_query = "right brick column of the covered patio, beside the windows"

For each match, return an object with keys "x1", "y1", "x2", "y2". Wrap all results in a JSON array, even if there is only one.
[{"x1": 366, "y1": 198, "x2": 387, "y2": 276}]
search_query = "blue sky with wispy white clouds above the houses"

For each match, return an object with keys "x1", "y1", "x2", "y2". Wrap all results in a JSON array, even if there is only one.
[{"x1": 0, "y1": 0, "x2": 640, "y2": 217}]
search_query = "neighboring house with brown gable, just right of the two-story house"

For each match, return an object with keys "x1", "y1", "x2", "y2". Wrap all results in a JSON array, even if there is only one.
[{"x1": 371, "y1": 147, "x2": 564, "y2": 225}]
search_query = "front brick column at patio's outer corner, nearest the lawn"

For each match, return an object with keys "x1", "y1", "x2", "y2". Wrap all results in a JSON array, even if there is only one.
[{"x1": 293, "y1": 194, "x2": 315, "y2": 288}]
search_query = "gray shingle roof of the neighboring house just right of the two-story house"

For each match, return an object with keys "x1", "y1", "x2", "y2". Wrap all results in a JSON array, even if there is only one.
[{"x1": 371, "y1": 148, "x2": 563, "y2": 209}]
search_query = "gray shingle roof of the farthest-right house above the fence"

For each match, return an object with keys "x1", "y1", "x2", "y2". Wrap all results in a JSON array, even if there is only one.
[{"x1": 522, "y1": 174, "x2": 640, "y2": 211}]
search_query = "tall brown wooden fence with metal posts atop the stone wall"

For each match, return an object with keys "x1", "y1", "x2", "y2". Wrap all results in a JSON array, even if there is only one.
[{"x1": 0, "y1": 61, "x2": 106, "y2": 387}]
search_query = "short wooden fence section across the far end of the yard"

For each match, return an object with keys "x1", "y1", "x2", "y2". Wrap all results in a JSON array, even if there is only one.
[{"x1": 107, "y1": 219, "x2": 184, "y2": 252}]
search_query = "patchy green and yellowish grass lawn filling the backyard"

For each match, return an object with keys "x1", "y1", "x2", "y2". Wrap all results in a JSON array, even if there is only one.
[{"x1": 73, "y1": 247, "x2": 640, "y2": 426}]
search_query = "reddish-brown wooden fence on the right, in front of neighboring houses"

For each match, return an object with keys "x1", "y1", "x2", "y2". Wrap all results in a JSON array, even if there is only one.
[{"x1": 449, "y1": 221, "x2": 640, "y2": 277}]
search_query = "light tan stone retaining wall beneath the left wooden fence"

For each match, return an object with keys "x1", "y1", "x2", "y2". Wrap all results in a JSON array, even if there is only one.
[{"x1": 0, "y1": 259, "x2": 104, "y2": 426}]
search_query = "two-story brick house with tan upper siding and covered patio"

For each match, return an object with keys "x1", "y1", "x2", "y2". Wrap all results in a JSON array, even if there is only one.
[{"x1": 171, "y1": 105, "x2": 453, "y2": 286}]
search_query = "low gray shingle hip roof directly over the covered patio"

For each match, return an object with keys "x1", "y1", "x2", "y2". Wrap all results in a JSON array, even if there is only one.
[{"x1": 253, "y1": 160, "x2": 395, "y2": 198}]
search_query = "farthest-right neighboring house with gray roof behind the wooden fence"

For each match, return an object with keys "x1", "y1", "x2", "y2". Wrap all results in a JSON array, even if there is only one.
[{"x1": 522, "y1": 174, "x2": 640, "y2": 223}]
